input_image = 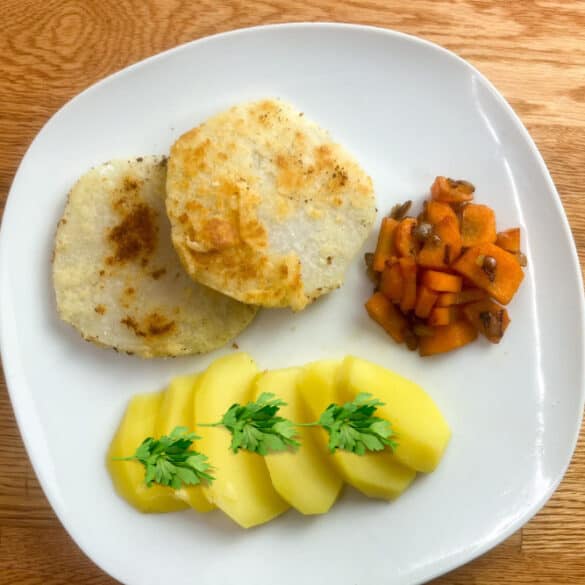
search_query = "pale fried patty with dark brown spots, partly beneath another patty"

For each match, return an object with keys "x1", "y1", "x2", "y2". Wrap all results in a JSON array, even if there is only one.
[{"x1": 53, "y1": 156, "x2": 256, "y2": 357}]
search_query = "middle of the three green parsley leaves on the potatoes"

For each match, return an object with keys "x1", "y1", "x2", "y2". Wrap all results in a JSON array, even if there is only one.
[{"x1": 218, "y1": 392, "x2": 300, "y2": 455}]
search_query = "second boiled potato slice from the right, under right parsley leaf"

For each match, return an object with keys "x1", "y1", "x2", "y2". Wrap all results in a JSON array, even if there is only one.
[{"x1": 298, "y1": 360, "x2": 416, "y2": 500}]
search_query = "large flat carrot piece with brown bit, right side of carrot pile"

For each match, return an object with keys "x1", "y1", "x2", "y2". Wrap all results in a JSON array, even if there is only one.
[{"x1": 452, "y1": 244, "x2": 524, "y2": 305}]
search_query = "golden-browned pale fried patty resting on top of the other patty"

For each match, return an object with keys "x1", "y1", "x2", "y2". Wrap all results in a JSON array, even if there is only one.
[{"x1": 167, "y1": 100, "x2": 375, "y2": 310}]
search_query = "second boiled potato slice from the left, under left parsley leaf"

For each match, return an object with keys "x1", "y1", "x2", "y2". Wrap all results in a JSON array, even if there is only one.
[{"x1": 155, "y1": 374, "x2": 215, "y2": 512}]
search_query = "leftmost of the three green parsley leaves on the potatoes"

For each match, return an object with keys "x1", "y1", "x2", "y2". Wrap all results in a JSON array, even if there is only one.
[{"x1": 115, "y1": 427, "x2": 215, "y2": 489}]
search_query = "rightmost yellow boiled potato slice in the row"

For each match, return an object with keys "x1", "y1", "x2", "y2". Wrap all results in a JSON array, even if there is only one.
[{"x1": 339, "y1": 356, "x2": 451, "y2": 472}]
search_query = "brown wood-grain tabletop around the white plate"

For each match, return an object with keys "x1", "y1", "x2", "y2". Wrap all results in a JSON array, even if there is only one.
[{"x1": 0, "y1": 0, "x2": 585, "y2": 585}]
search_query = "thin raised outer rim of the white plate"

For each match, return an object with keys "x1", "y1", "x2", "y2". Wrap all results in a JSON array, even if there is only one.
[{"x1": 0, "y1": 21, "x2": 585, "y2": 585}]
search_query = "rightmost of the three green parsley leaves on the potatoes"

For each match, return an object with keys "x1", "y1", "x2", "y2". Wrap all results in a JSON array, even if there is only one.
[{"x1": 319, "y1": 392, "x2": 398, "y2": 455}]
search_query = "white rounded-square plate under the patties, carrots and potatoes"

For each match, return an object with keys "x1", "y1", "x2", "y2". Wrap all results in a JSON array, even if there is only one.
[{"x1": 0, "y1": 24, "x2": 584, "y2": 585}]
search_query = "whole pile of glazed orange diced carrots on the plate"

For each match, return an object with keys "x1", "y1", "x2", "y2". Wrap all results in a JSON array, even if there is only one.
[{"x1": 365, "y1": 177, "x2": 526, "y2": 356}]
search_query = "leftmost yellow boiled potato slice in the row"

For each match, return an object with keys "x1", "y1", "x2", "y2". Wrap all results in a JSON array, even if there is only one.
[{"x1": 107, "y1": 392, "x2": 188, "y2": 512}]
